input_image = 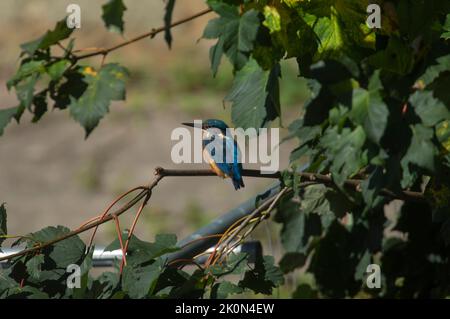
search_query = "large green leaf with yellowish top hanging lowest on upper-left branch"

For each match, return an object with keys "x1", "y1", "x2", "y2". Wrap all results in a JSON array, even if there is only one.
[{"x1": 69, "y1": 64, "x2": 128, "y2": 137}]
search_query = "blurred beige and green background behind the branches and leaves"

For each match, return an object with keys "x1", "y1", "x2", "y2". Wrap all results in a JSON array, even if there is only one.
[{"x1": 0, "y1": 0, "x2": 308, "y2": 262}]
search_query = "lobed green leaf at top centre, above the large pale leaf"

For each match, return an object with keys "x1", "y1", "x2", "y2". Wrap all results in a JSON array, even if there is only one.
[{"x1": 202, "y1": 1, "x2": 260, "y2": 75}]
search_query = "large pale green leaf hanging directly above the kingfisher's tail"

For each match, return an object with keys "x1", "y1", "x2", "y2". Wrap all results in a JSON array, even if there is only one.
[{"x1": 225, "y1": 59, "x2": 280, "y2": 129}]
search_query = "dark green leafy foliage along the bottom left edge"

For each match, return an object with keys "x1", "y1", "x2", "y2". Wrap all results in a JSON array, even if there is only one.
[{"x1": 0, "y1": 205, "x2": 283, "y2": 299}]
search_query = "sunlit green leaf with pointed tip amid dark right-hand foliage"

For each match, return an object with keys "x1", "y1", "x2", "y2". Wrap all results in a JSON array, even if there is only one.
[{"x1": 351, "y1": 70, "x2": 389, "y2": 144}]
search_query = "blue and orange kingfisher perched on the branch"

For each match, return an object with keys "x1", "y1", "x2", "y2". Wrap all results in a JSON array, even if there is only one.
[{"x1": 182, "y1": 119, "x2": 244, "y2": 190}]
